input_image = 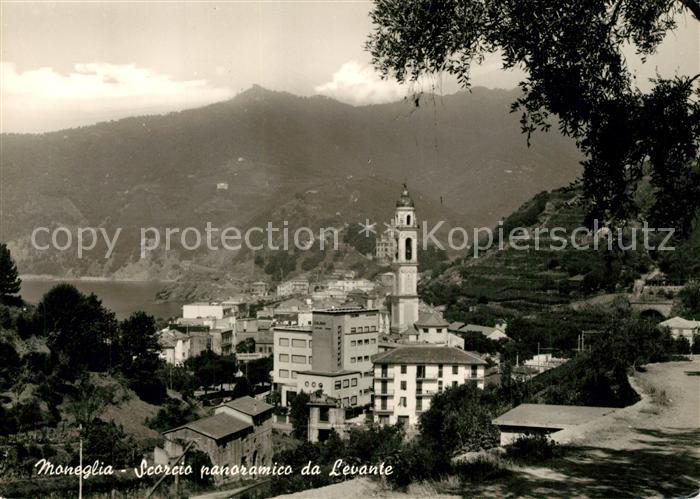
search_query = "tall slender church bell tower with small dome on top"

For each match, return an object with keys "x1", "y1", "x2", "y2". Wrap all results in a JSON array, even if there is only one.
[{"x1": 391, "y1": 184, "x2": 418, "y2": 333}]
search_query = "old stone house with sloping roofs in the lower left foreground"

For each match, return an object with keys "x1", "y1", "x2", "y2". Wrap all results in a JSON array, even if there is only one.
[{"x1": 154, "y1": 397, "x2": 273, "y2": 481}]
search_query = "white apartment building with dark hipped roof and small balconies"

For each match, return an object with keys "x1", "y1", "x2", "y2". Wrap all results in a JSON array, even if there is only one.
[{"x1": 374, "y1": 345, "x2": 486, "y2": 426}]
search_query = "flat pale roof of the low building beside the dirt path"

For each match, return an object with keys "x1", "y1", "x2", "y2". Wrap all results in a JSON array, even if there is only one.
[{"x1": 493, "y1": 404, "x2": 617, "y2": 429}]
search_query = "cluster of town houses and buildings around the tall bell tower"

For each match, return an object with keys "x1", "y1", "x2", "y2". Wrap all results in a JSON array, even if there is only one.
[{"x1": 159, "y1": 190, "x2": 636, "y2": 484}]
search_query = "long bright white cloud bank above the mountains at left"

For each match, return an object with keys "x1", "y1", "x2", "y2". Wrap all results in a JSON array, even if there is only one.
[{"x1": 0, "y1": 62, "x2": 232, "y2": 132}]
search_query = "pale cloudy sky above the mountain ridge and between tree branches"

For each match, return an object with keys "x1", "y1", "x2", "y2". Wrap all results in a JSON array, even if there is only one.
[{"x1": 0, "y1": 0, "x2": 700, "y2": 133}]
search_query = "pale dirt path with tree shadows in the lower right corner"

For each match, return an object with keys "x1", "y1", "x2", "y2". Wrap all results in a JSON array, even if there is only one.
[{"x1": 270, "y1": 356, "x2": 700, "y2": 499}]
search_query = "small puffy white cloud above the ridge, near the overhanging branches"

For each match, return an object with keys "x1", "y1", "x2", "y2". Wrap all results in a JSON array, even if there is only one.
[{"x1": 314, "y1": 61, "x2": 411, "y2": 105}]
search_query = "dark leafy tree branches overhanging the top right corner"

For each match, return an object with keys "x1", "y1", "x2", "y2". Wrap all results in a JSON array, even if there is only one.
[{"x1": 367, "y1": 0, "x2": 700, "y2": 235}]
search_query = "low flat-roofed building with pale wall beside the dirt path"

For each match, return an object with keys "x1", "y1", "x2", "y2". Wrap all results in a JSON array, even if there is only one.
[{"x1": 492, "y1": 404, "x2": 616, "y2": 445}]
